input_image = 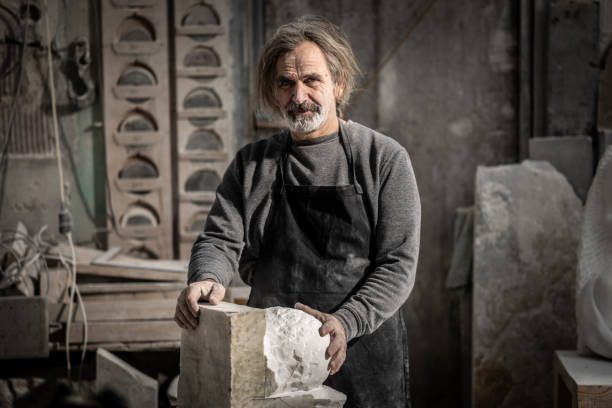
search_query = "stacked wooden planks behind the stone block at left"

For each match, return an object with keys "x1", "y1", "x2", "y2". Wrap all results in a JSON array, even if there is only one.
[{"x1": 40, "y1": 246, "x2": 187, "y2": 350}]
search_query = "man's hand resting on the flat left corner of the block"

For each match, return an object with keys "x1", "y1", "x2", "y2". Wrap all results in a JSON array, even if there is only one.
[{"x1": 174, "y1": 279, "x2": 225, "y2": 330}]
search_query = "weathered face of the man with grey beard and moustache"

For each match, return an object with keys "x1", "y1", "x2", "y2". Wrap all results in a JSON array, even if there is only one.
[{"x1": 274, "y1": 41, "x2": 339, "y2": 133}]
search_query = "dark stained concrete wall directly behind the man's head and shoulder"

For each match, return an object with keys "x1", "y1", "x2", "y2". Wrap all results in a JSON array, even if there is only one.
[{"x1": 264, "y1": 0, "x2": 518, "y2": 407}]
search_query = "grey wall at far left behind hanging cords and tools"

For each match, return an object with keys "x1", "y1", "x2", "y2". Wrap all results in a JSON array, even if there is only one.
[{"x1": 0, "y1": 0, "x2": 105, "y2": 242}]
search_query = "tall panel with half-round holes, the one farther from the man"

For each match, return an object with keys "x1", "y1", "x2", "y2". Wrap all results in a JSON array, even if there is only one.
[{"x1": 102, "y1": 0, "x2": 174, "y2": 258}]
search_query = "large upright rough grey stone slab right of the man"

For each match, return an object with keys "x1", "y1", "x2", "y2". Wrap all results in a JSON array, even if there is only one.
[{"x1": 472, "y1": 161, "x2": 582, "y2": 407}]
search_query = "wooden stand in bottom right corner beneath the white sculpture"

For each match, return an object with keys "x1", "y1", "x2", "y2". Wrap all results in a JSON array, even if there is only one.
[{"x1": 553, "y1": 350, "x2": 612, "y2": 408}]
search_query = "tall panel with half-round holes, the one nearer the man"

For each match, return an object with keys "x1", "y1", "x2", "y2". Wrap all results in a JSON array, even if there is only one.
[{"x1": 172, "y1": 0, "x2": 236, "y2": 259}]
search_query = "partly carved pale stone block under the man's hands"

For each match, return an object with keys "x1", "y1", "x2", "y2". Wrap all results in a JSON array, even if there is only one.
[{"x1": 178, "y1": 302, "x2": 346, "y2": 408}]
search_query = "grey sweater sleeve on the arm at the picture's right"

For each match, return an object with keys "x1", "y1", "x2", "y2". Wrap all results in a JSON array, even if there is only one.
[{"x1": 334, "y1": 149, "x2": 421, "y2": 341}]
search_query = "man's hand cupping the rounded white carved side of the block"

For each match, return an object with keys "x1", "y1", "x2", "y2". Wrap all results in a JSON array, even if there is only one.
[{"x1": 295, "y1": 302, "x2": 346, "y2": 375}]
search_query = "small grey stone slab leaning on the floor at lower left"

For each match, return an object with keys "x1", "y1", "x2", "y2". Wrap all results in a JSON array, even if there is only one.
[{"x1": 96, "y1": 348, "x2": 158, "y2": 408}]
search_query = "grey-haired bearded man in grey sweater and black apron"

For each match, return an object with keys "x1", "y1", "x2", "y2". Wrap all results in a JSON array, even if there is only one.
[{"x1": 175, "y1": 17, "x2": 420, "y2": 407}]
